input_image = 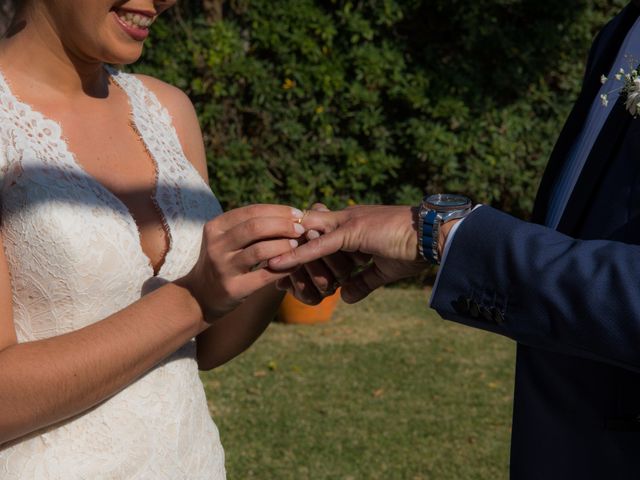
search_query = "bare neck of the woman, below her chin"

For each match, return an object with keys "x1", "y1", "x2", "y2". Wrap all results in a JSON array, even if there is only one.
[{"x1": 0, "y1": 8, "x2": 108, "y2": 97}]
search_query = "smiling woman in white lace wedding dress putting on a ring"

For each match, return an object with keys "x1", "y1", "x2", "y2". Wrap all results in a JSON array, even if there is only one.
[{"x1": 0, "y1": 0, "x2": 312, "y2": 480}]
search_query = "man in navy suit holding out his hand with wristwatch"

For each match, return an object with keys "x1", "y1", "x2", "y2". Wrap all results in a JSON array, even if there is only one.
[{"x1": 271, "y1": 2, "x2": 640, "y2": 480}]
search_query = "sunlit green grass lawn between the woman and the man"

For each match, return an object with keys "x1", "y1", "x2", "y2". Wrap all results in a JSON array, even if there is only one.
[{"x1": 202, "y1": 289, "x2": 515, "y2": 480}]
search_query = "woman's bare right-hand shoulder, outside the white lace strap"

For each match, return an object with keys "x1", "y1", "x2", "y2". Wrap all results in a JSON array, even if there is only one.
[{"x1": 134, "y1": 74, "x2": 207, "y2": 179}]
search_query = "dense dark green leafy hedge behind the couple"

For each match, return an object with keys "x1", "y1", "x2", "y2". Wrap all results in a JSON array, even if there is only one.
[{"x1": 134, "y1": 0, "x2": 625, "y2": 217}]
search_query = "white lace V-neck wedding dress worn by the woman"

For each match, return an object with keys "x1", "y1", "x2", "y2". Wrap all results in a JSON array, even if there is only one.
[{"x1": 0, "y1": 71, "x2": 225, "y2": 480}]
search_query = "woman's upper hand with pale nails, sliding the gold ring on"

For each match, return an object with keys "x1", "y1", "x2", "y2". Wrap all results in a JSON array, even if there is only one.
[{"x1": 176, "y1": 205, "x2": 305, "y2": 323}]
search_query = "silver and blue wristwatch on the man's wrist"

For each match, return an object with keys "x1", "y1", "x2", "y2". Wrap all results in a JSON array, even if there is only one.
[{"x1": 418, "y1": 193, "x2": 473, "y2": 265}]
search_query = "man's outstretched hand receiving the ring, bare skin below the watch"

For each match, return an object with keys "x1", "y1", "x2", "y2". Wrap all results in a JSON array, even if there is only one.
[{"x1": 269, "y1": 205, "x2": 428, "y2": 303}]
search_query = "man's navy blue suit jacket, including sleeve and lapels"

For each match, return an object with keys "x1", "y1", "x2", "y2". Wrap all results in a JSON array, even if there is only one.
[{"x1": 432, "y1": 5, "x2": 640, "y2": 480}]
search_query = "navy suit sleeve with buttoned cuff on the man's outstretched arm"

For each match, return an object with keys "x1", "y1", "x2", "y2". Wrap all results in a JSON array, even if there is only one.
[{"x1": 431, "y1": 207, "x2": 640, "y2": 371}]
